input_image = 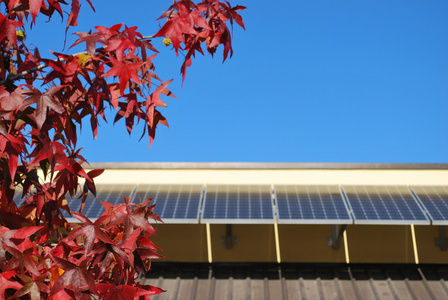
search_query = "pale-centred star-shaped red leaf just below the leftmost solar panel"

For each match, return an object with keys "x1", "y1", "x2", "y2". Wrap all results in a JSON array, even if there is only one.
[{"x1": 64, "y1": 212, "x2": 115, "y2": 255}]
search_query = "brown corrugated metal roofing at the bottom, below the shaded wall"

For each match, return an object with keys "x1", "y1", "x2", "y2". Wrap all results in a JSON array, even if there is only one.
[{"x1": 141, "y1": 264, "x2": 448, "y2": 300}]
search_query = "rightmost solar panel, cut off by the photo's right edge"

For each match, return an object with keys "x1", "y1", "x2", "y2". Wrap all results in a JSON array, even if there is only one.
[{"x1": 411, "y1": 186, "x2": 448, "y2": 225}]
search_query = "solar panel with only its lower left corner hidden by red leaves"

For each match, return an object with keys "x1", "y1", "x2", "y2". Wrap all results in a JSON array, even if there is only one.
[{"x1": 137, "y1": 185, "x2": 202, "y2": 224}]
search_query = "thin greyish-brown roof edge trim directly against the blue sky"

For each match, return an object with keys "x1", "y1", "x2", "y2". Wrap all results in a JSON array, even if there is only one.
[{"x1": 87, "y1": 162, "x2": 448, "y2": 170}]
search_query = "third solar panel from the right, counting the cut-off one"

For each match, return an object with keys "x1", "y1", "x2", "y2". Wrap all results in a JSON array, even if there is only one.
[{"x1": 274, "y1": 185, "x2": 353, "y2": 224}]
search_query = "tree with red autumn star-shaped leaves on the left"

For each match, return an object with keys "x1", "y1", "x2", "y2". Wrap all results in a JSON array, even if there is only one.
[{"x1": 0, "y1": 0, "x2": 244, "y2": 299}]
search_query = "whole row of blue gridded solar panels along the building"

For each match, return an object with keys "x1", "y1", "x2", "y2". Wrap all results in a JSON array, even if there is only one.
[{"x1": 14, "y1": 184, "x2": 448, "y2": 225}]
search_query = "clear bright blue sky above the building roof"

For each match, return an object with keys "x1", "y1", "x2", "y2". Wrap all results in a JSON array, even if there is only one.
[{"x1": 28, "y1": 0, "x2": 448, "y2": 163}]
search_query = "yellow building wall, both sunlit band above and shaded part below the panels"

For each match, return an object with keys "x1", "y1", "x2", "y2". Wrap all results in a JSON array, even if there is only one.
[{"x1": 88, "y1": 164, "x2": 448, "y2": 263}]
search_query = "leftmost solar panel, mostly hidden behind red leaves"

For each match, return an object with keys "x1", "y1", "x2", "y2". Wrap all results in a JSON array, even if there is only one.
[{"x1": 63, "y1": 184, "x2": 135, "y2": 222}]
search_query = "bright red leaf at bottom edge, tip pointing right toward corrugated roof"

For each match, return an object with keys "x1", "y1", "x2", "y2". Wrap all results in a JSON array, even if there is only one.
[{"x1": 96, "y1": 283, "x2": 165, "y2": 300}]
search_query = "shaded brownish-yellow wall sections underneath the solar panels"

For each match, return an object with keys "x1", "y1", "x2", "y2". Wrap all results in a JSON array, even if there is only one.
[{"x1": 153, "y1": 224, "x2": 448, "y2": 264}]
